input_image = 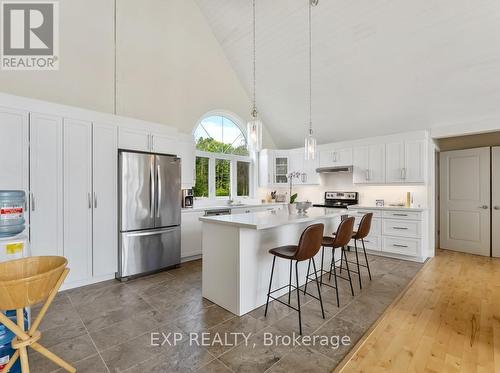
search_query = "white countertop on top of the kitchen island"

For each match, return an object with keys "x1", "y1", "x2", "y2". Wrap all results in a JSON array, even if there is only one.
[{"x1": 200, "y1": 207, "x2": 348, "y2": 230}]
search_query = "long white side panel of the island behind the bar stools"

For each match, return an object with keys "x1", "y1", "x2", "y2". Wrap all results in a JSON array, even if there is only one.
[{"x1": 239, "y1": 217, "x2": 340, "y2": 316}]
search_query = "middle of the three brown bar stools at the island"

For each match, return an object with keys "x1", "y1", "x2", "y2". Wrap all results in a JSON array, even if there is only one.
[{"x1": 304, "y1": 217, "x2": 354, "y2": 307}]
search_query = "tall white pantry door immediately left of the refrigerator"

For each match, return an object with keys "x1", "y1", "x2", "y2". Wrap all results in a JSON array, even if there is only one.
[{"x1": 92, "y1": 123, "x2": 118, "y2": 277}]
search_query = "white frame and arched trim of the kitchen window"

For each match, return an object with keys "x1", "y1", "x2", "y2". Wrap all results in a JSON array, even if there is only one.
[{"x1": 192, "y1": 110, "x2": 258, "y2": 201}]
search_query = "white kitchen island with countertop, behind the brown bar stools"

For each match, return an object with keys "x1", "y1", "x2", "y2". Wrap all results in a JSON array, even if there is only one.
[{"x1": 200, "y1": 207, "x2": 347, "y2": 316}]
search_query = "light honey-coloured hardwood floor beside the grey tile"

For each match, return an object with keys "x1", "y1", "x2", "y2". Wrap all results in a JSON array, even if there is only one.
[{"x1": 336, "y1": 250, "x2": 500, "y2": 373}]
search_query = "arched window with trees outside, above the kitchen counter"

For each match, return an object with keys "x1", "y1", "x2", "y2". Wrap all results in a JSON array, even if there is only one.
[{"x1": 193, "y1": 115, "x2": 253, "y2": 198}]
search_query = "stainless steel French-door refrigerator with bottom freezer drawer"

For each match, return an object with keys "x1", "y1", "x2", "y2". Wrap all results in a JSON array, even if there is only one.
[{"x1": 117, "y1": 151, "x2": 182, "y2": 280}]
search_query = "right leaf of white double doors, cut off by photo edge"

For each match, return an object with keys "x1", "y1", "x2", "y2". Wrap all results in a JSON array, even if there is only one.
[{"x1": 491, "y1": 147, "x2": 500, "y2": 258}]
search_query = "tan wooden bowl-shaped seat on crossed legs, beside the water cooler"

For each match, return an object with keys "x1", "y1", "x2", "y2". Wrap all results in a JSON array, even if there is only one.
[{"x1": 0, "y1": 256, "x2": 76, "y2": 373}]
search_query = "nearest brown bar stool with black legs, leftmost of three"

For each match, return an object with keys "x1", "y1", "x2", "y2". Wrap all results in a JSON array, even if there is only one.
[{"x1": 264, "y1": 224, "x2": 325, "y2": 335}]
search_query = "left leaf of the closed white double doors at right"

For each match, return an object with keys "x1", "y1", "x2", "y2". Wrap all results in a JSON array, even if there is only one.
[{"x1": 440, "y1": 148, "x2": 490, "y2": 256}]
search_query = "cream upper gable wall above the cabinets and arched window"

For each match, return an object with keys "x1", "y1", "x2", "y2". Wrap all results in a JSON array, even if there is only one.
[{"x1": 0, "y1": 0, "x2": 274, "y2": 147}]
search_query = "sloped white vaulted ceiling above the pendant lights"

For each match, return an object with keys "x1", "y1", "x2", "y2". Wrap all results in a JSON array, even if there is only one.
[{"x1": 196, "y1": 0, "x2": 500, "y2": 147}]
